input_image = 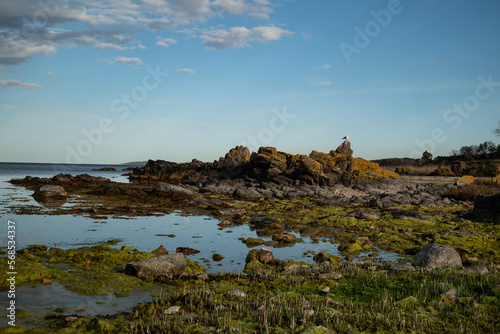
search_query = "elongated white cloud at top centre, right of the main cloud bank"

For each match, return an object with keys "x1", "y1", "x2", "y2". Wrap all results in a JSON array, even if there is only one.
[{"x1": 200, "y1": 27, "x2": 293, "y2": 50}]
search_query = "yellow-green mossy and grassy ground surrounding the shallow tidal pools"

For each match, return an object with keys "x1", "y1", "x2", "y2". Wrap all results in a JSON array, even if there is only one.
[{"x1": 0, "y1": 181, "x2": 500, "y2": 334}]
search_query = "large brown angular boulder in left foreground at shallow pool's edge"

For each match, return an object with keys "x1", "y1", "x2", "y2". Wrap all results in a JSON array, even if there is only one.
[{"x1": 125, "y1": 253, "x2": 187, "y2": 279}]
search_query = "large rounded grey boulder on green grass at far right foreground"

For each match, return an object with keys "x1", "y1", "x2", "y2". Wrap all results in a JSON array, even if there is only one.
[{"x1": 414, "y1": 243, "x2": 462, "y2": 269}]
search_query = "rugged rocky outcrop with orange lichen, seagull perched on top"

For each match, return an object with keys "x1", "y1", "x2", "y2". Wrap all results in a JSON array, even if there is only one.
[{"x1": 130, "y1": 141, "x2": 398, "y2": 188}]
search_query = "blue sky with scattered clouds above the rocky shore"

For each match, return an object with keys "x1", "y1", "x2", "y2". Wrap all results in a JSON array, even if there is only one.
[{"x1": 0, "y1": 0, "x2": 500, "y2": 163}]
